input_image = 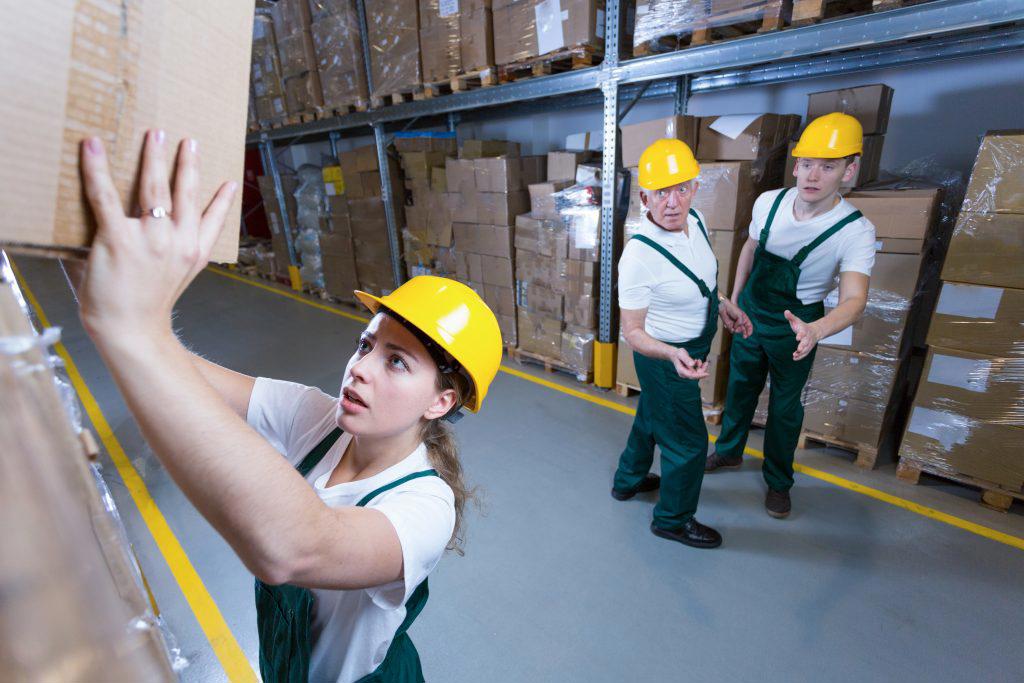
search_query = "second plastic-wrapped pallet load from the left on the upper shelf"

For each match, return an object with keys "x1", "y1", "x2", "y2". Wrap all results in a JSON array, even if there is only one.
[{"x1": 270, "y1": 0, "x2": 324, "y2": 122}]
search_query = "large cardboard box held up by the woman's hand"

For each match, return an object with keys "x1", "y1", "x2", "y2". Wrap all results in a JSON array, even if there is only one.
[{"x1": 0, "y1": 0, "x2": 253, "y2": 262}]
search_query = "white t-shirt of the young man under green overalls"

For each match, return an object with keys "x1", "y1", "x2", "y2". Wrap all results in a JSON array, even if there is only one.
[{"x1": 748, "y1": 187, "x2": 874, "y2": 303}]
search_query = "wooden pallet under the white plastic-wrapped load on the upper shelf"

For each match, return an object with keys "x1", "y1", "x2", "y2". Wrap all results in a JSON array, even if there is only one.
[{"x1": 633, "y1": 0, "x2": 795, "y2": 57}]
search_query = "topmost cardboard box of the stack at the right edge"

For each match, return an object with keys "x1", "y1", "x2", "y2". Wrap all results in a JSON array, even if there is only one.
[{"x1": 963, "y1": 130, "x2": 1024, "y2": 213}]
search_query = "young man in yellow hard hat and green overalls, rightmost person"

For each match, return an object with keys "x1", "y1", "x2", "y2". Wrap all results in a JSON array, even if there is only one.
[{"x1": 705, "y1": 113, "x2": 874, "y2": 518}]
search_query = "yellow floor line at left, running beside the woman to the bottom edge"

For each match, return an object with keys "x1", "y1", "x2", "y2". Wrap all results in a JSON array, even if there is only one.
[{"x1": 11, "y1": 263, "x2": 257, "y2": 682}]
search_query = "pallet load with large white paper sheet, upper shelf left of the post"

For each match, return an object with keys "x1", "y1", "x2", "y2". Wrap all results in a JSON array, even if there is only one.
[{"x1": 494, "y1": 0, "x2": 604, "y2": 83}]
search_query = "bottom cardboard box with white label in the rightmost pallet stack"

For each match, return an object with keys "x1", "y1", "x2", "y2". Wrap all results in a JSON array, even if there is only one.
[{"x1": 899, "y1": 401, "x2": 1024, "y2": 492}]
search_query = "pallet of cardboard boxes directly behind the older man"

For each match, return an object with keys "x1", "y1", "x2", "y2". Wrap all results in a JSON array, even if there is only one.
[{"x1": 615, "y1": 114, "x2": 800, "y2": 424}]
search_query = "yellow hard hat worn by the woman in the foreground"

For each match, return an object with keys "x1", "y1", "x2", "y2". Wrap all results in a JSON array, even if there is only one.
[{"x1": 355, "y1": 275, "x2": 502, "y2": 413}]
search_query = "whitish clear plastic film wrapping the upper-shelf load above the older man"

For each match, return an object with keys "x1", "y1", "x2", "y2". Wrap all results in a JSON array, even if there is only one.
[{"x1": 633, "y1": 0, "x2": 783, "y2": 56}]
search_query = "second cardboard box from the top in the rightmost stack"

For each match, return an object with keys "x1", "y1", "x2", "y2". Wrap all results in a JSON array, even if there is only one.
[{"x1": 942, "y1": 211, "x2": 1024, "y2": 289}]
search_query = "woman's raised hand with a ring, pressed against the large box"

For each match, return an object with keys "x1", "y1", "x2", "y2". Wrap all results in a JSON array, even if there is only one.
[{"x1": 78, "y1": 130, "x2": 237, "y2": 339}]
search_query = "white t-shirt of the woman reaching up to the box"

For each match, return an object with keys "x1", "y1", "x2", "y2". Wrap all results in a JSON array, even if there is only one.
[{"x1": 241, "y1": 377, "x2": 455, "y2": 683}]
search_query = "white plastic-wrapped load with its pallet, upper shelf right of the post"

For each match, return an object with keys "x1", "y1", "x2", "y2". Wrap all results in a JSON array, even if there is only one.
[{"x1": 633, "y1": 0, "x2": 792, "y2": 57}]
